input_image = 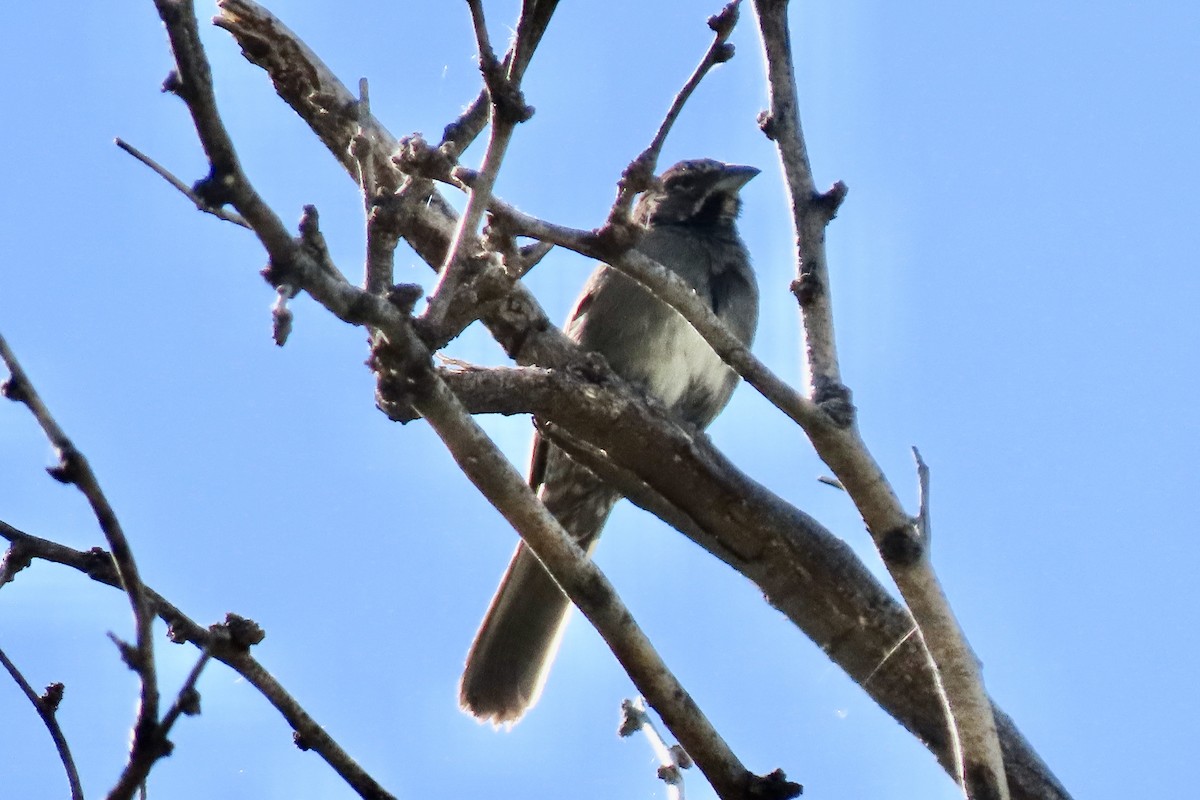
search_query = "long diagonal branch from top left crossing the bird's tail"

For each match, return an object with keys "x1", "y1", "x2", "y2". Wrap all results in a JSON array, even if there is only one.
[{"x1": 145, "y1": 0, "x2": 791, "y2": 798}]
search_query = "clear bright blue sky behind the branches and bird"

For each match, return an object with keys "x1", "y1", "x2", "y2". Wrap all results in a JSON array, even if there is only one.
[{"x1": 0, "y1": 0, "x2": 1200, "y2": 800}]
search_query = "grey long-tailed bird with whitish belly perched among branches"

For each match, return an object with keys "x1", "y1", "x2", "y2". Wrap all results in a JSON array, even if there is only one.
[{"x1": 460, "y1": 160, "x2": 758, "y2": 724}]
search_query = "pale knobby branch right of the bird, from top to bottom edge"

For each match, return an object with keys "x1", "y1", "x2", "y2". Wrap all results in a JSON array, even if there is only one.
[{"x1": 755, "y1": 0, "x2": 1009, "y2": 800}]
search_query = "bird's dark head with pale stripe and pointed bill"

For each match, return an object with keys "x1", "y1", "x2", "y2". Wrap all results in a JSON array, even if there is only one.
[{"x1": 634, "y1": 158, "x2": 761, "y2": 227}]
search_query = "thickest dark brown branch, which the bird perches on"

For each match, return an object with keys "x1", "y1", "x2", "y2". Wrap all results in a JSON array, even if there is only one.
[{"x1": 378, "y1": 365, "x2": 1069, "y2": 800}]
